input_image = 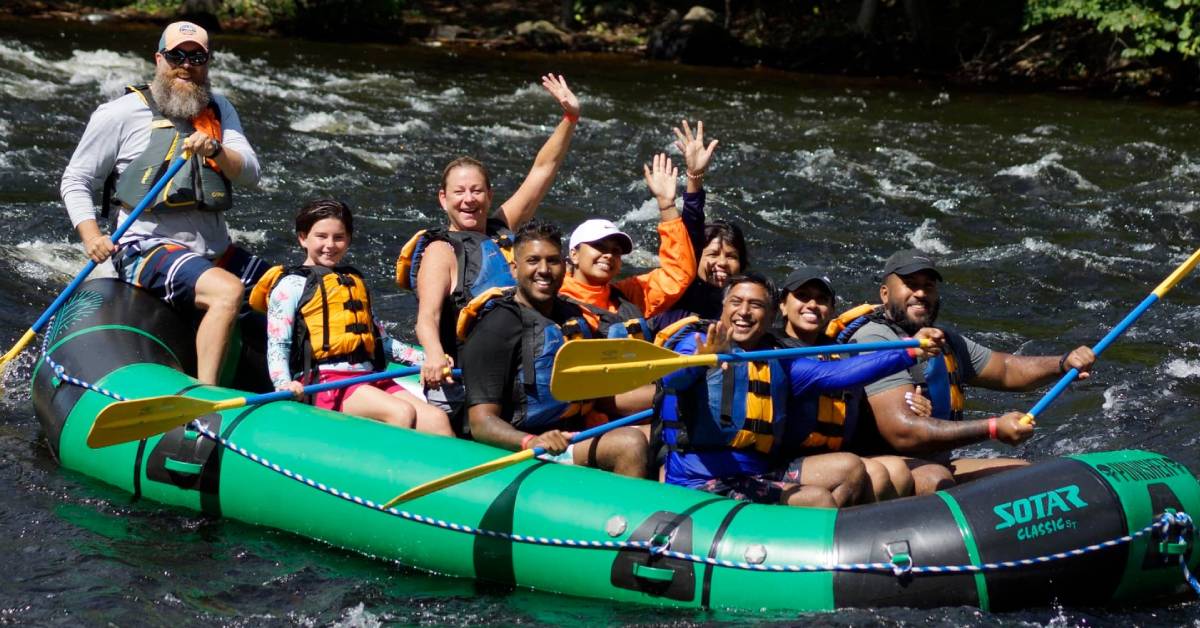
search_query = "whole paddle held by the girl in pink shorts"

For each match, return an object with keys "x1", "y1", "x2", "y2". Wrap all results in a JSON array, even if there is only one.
[{"x1": 81, "y1": 366, "x2": 458, "y2": 449}]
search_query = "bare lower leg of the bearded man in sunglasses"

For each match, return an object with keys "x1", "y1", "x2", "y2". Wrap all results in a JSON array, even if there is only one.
[{"x1": 196, "y1": 267, "x2": 245, "y2": 384}]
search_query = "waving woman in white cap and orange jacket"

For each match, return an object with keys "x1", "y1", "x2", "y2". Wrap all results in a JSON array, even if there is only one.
[{"x1": 559, "y1": 154, "x2": 696, "y2": 339}]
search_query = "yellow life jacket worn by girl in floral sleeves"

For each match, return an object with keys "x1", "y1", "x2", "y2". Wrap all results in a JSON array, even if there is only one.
[{"x1": 250, "y1": 265, "x2": 383, "y2": 373}]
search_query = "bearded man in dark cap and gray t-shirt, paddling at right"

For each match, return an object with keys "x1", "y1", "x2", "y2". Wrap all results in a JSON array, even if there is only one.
[{"x1": 851, "y1": 250, "x2": 1096, "y2": 494}]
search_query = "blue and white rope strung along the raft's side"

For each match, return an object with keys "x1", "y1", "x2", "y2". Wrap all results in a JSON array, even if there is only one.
[{"x1": 42, "y1": 333, "x2": 1200, "y2": 596}]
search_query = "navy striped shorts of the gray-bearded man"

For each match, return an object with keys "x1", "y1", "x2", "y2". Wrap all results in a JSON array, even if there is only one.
[{"x1": 113, "y1": 244, "x2": 268, "y2": 307}]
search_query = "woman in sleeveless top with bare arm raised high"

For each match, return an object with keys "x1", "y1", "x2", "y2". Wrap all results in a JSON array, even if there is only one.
[{"x1": 396, "y1": 74, "x2": 580, "y2": 432}]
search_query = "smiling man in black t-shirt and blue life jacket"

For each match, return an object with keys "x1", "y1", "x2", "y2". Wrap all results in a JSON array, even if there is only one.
[{"x1": 461, "y1": 221, "x2": 649, "y2": 477}]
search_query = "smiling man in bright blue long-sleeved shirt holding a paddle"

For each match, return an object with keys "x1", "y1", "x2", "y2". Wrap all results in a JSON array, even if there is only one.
[{"x1": 660, "y1": 273, "x2": 941, "y2": 507}]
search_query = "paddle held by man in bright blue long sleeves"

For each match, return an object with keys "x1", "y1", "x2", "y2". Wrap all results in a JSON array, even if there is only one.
[{"x1": 550, "y1": 339, "x2": 932, "y2": 401}]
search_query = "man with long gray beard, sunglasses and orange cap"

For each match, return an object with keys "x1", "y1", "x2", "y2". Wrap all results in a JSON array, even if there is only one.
[{"x1": 60, "y1": 22, "x2": 266, "y2": 384}]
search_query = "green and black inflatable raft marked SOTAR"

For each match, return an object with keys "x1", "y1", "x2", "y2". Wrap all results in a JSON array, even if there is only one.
[{"x1": 32, "y1": 280, "x2": 1200, "y2": 611}]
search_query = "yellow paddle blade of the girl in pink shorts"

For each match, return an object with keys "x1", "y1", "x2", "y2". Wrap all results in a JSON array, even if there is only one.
[{"x1": 88, "y1": 395, "x2": 246, "y2": 449}]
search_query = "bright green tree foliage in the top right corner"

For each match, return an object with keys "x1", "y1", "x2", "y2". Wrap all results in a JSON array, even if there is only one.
[{"x1": 1025, "y1": 0, "x2": 1200, "y2": 59}]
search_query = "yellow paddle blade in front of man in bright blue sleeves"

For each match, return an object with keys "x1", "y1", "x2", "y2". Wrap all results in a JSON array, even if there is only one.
[{"x1": 550, "y1": 339, "x2": 718, "y2": 401}]
